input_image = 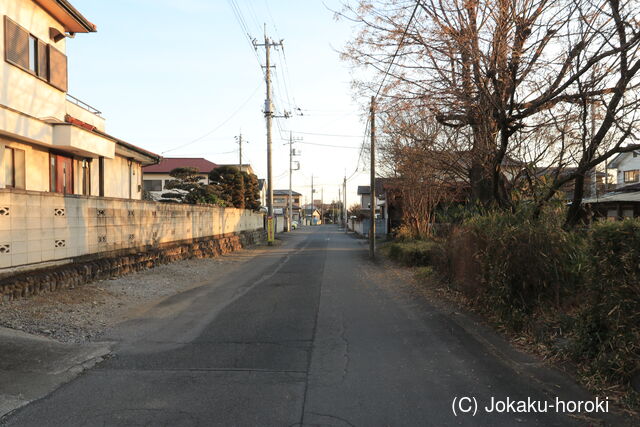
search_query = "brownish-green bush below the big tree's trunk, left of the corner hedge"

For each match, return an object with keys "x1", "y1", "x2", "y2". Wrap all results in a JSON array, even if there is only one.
[{"x1": 463, "y1": 212, "x2": 586, "y2": 331}]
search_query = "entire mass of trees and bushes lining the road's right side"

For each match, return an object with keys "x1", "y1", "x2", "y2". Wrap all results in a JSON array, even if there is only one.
[{"x1": 336, "y1": 0, "x2": 640, "y2": 414}]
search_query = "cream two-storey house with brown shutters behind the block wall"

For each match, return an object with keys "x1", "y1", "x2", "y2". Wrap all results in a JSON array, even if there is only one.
[{"x1": 0, "y1": 0, "x2": 159, "y2": 199}]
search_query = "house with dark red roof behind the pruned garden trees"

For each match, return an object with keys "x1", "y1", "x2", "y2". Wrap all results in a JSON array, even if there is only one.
[{"x1": 142, "y1": 157, "x2": 218, "y2": 198}]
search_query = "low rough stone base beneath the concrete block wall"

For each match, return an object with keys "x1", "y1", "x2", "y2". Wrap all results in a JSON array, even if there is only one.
[{"x1": 0, "y1": 230, "x2": 266, "y2": 302}]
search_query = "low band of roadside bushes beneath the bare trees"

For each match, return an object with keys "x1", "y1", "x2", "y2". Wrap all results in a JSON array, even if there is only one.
[{"x1": 384, "y1": 212, "x2": 640, "y2": 410}]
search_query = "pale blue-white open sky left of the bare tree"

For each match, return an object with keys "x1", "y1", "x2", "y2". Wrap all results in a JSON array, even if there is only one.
[{"x1": 67, "y1": 0, "x2": 368, "y2": 205}]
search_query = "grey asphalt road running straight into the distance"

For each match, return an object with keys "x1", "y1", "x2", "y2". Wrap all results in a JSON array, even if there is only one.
[{"x1": 6, "y1": 226, "x2": 604, "y2": 427}]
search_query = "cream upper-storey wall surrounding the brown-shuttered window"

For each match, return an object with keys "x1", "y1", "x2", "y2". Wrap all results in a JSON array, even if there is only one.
[{"x1": 0, "y1": 0, "x2": 66, "y2": 122}]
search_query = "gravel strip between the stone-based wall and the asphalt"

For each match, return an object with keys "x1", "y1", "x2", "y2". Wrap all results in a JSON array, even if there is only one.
[{"x1": 0, "y1": 247, "x2": 261, "y2": 343}]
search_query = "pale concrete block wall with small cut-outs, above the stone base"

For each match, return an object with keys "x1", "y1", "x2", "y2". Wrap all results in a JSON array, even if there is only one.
[{"x1": 0, "y1": 189, "x2": 263, "y2": 269}]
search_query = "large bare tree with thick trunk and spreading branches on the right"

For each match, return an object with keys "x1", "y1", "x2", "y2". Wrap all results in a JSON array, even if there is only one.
[{"x1": 341, "y1": 0, "x2": 640, "y2": 221}]
